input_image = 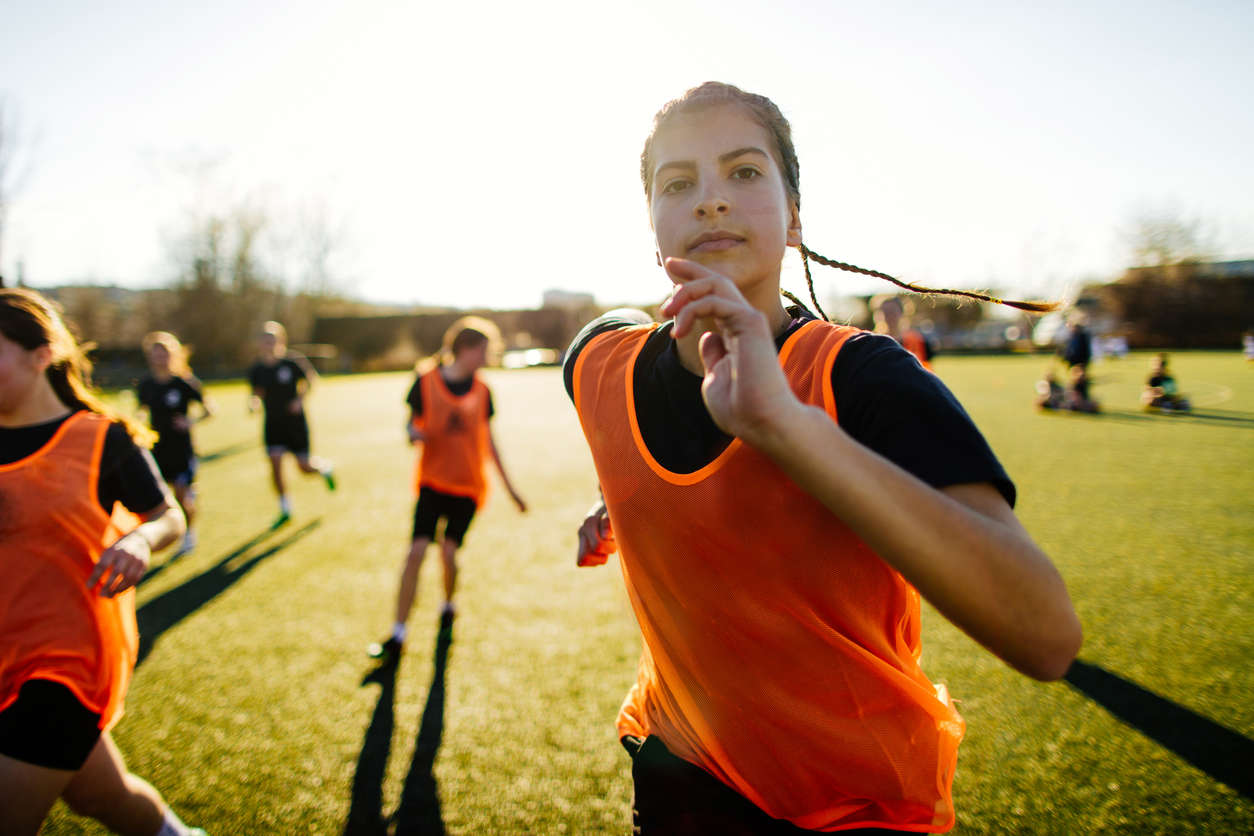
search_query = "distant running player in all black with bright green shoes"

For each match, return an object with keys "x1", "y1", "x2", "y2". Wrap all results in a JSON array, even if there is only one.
[{"x1": 248, "y1": 321, "x2": 335, "y2": 528}]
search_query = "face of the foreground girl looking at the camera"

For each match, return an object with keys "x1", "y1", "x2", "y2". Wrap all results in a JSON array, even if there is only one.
[{"x1": 650, "y1": 104, "x2": 801, "y2": 293}]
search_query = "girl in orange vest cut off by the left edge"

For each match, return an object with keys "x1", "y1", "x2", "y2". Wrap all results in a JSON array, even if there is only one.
[{"x1": 0, "y1": 290, "x2": 203, "y2": 836}]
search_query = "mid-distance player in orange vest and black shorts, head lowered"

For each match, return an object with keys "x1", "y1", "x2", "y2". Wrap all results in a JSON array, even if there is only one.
[{"x1": 369, "y1": 316, "x2": 527, "y2": 661}]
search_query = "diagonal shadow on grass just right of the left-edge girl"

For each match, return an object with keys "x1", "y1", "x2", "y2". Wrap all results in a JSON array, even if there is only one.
[{"x1": 135, "y1": 518, "x2": 322, "y2": 667}]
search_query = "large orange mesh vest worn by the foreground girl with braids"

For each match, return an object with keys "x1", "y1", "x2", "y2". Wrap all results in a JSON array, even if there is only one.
[{"x1": 574, "y1": 322, "x2": 964, "y2": 832}]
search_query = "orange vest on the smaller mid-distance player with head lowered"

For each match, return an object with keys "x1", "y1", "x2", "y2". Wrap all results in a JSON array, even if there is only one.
[{"x1": 414, "y1": 368, "x2": 489, "y2": 506}]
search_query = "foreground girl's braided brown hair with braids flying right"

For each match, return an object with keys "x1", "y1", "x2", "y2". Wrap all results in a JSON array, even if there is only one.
[{"x1": 640, "y1": 81, "x2": 1058, "y2": 320}]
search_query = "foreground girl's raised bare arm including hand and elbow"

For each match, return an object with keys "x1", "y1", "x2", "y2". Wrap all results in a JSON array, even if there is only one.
[{"x1": 662, "y1": 259, "x2": 1081, "y2": 679}]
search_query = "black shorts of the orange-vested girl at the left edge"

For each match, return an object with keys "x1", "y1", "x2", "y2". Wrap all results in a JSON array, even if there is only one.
[{"x1": 0, "y1": 679, "x2": 100, "y2": 772}]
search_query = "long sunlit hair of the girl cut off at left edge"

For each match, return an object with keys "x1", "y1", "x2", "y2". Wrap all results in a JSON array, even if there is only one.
[{"x1": 0, "y1": 287, "x2": 157, "y2": 446}]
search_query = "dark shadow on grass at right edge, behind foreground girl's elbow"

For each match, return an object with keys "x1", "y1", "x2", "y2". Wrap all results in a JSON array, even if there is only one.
[{"x1": 1066, "y1": 659, "x2": 1254, "y2": 798}]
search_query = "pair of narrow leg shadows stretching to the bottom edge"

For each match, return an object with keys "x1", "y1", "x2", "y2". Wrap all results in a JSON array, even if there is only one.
[{"x1": 344, "y1": 630, "x2": 453, "y2": 836}]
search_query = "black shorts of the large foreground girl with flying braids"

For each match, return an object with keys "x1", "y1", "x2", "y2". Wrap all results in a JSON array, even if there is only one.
[{"x1": 622, "y1": 734, "x2": 902, "y2": 836}]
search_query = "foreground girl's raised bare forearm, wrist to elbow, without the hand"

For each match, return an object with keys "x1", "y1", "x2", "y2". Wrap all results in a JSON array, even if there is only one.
[{"x1": 746, "y1": 401, "x2": 1081, "y2": 679}]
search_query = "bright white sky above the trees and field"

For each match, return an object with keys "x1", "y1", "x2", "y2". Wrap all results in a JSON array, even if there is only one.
[{"x1": 0, "y1": 0, "x2": 1254, "y2": 307}]
